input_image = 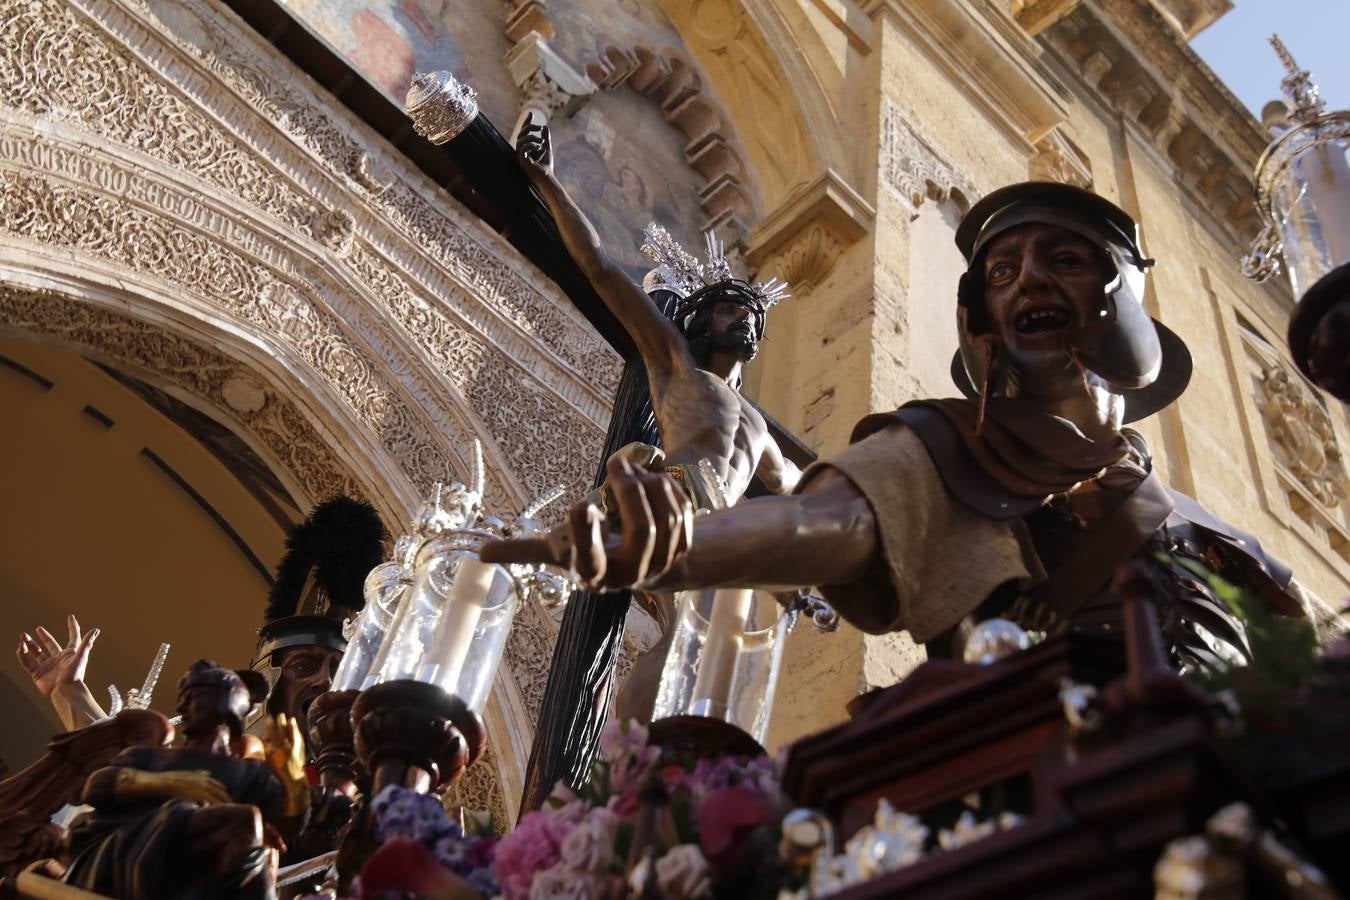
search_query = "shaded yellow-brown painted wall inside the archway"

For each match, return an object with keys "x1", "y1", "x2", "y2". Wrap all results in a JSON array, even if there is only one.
[{"x1": 0, "y1": 339, "x2": 285, "y2": 769}]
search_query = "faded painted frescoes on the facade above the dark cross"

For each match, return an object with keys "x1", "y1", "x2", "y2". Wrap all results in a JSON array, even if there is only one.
[{"x1": 286, "y1": 0, "x2": 705, "y2": 279}]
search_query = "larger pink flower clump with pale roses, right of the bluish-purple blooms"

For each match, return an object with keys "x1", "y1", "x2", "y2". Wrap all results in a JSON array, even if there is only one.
[{"x1": 497, "y1": 722, "x2": 791, "y2": 900}]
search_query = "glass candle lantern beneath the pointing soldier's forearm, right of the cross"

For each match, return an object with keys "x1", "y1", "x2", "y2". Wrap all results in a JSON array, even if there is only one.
[{"x1": 652, "y1": 588, "x2": 788, "y2": 743}]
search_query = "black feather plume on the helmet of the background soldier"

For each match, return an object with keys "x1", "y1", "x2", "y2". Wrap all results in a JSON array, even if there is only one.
[{"x1": 265, "y1": 497, "x2": 387, "y2": 622}]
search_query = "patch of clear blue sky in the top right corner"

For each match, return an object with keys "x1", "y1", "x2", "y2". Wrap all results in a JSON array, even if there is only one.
[{"x1": 1191, "y1": 0, "x2": 1350, "y2": 117}]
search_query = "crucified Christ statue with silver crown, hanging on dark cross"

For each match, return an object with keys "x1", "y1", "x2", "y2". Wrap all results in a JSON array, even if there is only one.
[{"x1": 516, "y1": 114, "x2": 801, "y2": 718}]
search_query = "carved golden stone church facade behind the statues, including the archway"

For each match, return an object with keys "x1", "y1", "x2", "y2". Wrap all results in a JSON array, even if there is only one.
[{"x1": 0, "y1": 0, "x2": 1350, "y2": 811}]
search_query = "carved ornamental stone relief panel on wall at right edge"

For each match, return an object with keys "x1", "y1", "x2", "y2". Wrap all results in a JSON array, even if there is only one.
[{"x1": 1258, "y1": 366, "x2": 1347, "y2": 509}]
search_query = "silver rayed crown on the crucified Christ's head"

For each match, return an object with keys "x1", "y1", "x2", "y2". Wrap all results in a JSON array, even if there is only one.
[{"x1": 641, "y1": 223, "x2": 791, "y2": 331}]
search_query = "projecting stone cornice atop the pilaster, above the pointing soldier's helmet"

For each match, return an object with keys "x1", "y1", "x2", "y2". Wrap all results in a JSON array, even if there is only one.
[{"x1": 863, "y1": 0, "x2": 1069, "y2": 157}]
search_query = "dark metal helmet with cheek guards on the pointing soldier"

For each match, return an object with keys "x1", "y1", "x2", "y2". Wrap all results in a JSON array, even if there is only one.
[{"x1": 952, "y1": 181, "x2": 1191, "y2": 422}]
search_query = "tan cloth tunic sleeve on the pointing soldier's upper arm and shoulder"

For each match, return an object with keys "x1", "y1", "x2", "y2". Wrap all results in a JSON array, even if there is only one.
[{"x1": 798, "y1": 422, "x2": 1045, "y2": 642}]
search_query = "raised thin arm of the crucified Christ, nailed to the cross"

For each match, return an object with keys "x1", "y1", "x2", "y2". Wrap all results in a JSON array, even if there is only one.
[{"x1": 516, "y1": 119, "x2": 689, "y2": 372}]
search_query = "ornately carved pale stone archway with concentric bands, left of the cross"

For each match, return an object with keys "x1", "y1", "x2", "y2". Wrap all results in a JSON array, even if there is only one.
[{"x1": 0, "y1": 0, "x2": 618, "y2": 820}]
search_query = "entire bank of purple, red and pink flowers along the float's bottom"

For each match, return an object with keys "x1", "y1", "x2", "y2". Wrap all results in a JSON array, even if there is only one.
[{"x1": 321, "y1": 722, "x2": 803, "y2": 900}]
